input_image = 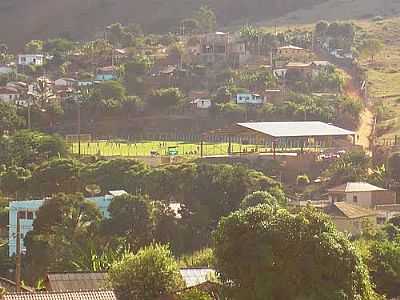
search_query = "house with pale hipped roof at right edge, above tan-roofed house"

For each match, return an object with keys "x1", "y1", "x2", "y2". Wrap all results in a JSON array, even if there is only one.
[{"x1": 328, "y1": 182, "x2": 396, "y2": 209}]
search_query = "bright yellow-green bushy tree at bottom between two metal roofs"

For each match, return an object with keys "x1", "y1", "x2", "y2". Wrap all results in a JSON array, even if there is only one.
[{"x1": 108, "y1": 244, "x2": 183, "y2": 300}]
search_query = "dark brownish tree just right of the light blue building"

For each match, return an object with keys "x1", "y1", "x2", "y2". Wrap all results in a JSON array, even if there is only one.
[{"x1": 103, "y1": 194, "x2": 152, "y2": 250}]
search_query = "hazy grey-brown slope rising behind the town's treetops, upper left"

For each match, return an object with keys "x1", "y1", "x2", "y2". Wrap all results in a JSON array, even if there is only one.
[{"x1": 0, "y1": 0, "x2": 326, "y2": 47}]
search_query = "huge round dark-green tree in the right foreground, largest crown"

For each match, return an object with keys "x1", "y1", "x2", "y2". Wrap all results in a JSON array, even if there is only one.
[{"x1": 214, "y1": 206, "x2": 374, "y2": 300}]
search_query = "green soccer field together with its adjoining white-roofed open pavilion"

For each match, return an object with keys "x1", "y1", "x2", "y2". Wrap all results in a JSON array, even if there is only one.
[{"x1": 67, "y1": 121, "x2": 356, "y2": 157}]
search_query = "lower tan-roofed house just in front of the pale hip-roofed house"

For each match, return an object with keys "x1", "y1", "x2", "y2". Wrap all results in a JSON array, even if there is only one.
[{"x1": 325, "y1": 202, "x2": 377, "y2": 235}]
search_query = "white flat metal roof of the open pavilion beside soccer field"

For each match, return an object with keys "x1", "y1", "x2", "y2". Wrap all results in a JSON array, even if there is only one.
[{"x1": 237, "y1": 121, "x2": 355, "y2": 137}]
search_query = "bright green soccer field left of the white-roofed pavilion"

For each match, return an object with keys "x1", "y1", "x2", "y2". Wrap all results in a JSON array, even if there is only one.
[{"x1": 70, "y1": 141, "x2": 261, "y2": 157}]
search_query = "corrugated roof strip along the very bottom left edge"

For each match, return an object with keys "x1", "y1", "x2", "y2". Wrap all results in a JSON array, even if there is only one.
[{"x1": 2, "y1": 290, "x2": 117, "y2": 300}]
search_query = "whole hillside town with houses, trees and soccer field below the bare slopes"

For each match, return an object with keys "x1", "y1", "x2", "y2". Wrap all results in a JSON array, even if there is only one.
[{"x1": 0, "y1": 6, "x2": 400, "y2": 300}]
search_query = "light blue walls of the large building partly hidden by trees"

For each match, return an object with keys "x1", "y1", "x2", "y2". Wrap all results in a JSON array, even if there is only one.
[{"x1": 8, "y1": 195, "x2": 113, "y2": 256}]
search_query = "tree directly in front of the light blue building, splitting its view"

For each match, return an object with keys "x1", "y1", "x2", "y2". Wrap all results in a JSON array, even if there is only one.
[{"x1": 25, "y1": 194, "x2": 101, "y2": 278}]
